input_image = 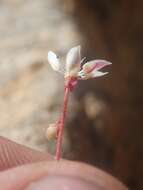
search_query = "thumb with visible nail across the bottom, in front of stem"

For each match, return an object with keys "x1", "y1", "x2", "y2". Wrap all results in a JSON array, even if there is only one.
[{"x1": 0, "y1": 161, "x2": 127, "y2": 190}]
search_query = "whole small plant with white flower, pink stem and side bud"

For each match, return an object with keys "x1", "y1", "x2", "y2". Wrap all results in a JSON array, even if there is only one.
[{"x1": 47, "y1": 46, "x2": 112, "y2": 160}]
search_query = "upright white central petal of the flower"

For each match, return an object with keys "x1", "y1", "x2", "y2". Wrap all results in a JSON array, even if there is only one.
[{"x1": 66, "y1": 46, "x2": 81, "y2": 74}]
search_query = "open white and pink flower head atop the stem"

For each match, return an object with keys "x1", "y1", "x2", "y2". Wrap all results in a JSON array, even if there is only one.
[{"x1": 48, "y1": 46, "x2": 112, "y2": 80}]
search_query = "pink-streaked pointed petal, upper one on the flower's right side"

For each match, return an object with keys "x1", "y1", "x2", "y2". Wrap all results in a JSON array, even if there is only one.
[{"x1": 82, "y1": 59, "x2": 112, "y2": 74}]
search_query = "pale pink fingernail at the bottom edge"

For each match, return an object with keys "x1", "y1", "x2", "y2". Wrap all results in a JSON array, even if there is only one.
[{"x1": 25, "y1": 176, "x2": 98, "y2": 190}]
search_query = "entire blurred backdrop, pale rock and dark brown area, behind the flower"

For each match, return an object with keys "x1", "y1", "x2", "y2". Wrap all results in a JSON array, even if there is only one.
[{"x1": 0, "y1": 0, "x2": 143, "y2": 190}]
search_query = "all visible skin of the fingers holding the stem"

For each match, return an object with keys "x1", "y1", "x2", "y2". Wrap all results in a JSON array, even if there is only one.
[{"x1": 0, "y1": 137, "x2": 127, "y2": 190}]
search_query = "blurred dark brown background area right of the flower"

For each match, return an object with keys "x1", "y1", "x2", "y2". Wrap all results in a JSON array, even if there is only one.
[{"x1": 62, "y1": 0, "x2": 143, "y2": 190}]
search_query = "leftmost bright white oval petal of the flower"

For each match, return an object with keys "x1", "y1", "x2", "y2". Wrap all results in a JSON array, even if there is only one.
[{"x1": 47, "y1": 51, "x2": 60, "y2": 71}]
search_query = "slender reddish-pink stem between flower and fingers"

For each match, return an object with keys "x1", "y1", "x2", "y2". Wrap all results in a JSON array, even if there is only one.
[{"x1": 55, "y1": 86, "x2": 70, "y2": 160}]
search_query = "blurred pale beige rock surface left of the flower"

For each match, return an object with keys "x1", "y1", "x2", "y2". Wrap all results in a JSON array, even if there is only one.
[{"x1": 0, "y1": 0, "x2": 78, "y2": 150}]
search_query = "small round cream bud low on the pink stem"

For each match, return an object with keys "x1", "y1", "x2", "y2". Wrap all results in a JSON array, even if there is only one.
[{"x1": 46, "y1": 123, "x2": 57, "y2": 141}]
